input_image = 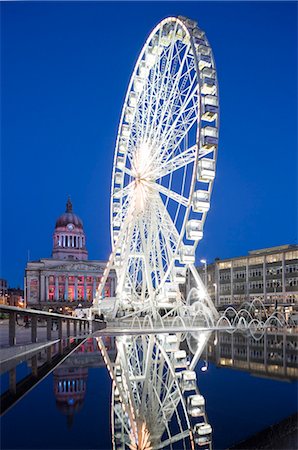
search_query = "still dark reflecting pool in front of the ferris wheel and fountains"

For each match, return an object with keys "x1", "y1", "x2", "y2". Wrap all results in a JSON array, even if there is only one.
[{"x1": 1, "y1": 332, "x2": 298, "y2": 450}]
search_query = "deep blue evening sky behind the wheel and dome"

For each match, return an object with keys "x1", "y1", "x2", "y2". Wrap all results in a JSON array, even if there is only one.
[{"x1": 1, "y1": 2, "x2": 297, "y2": 286}]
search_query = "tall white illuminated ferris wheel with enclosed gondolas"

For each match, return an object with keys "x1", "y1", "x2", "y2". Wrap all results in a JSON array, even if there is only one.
[{"x1": 98, "y1": 16, "x2": 219, "y2": 314}]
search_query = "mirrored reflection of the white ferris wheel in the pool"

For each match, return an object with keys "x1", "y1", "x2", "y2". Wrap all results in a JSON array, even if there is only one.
[{"x1": 97, "y1": 333, "x2": 212, "y2": 450}]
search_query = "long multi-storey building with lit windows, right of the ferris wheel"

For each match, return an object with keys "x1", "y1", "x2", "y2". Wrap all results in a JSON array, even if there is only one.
[{"x1": 193, "y1": 245, "x2": 298, "y2": 308}]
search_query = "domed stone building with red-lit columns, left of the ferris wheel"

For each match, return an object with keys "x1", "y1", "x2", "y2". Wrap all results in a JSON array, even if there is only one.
[{"x1": 25, "y1": 199, "x2": 116, "y2": 313}]
